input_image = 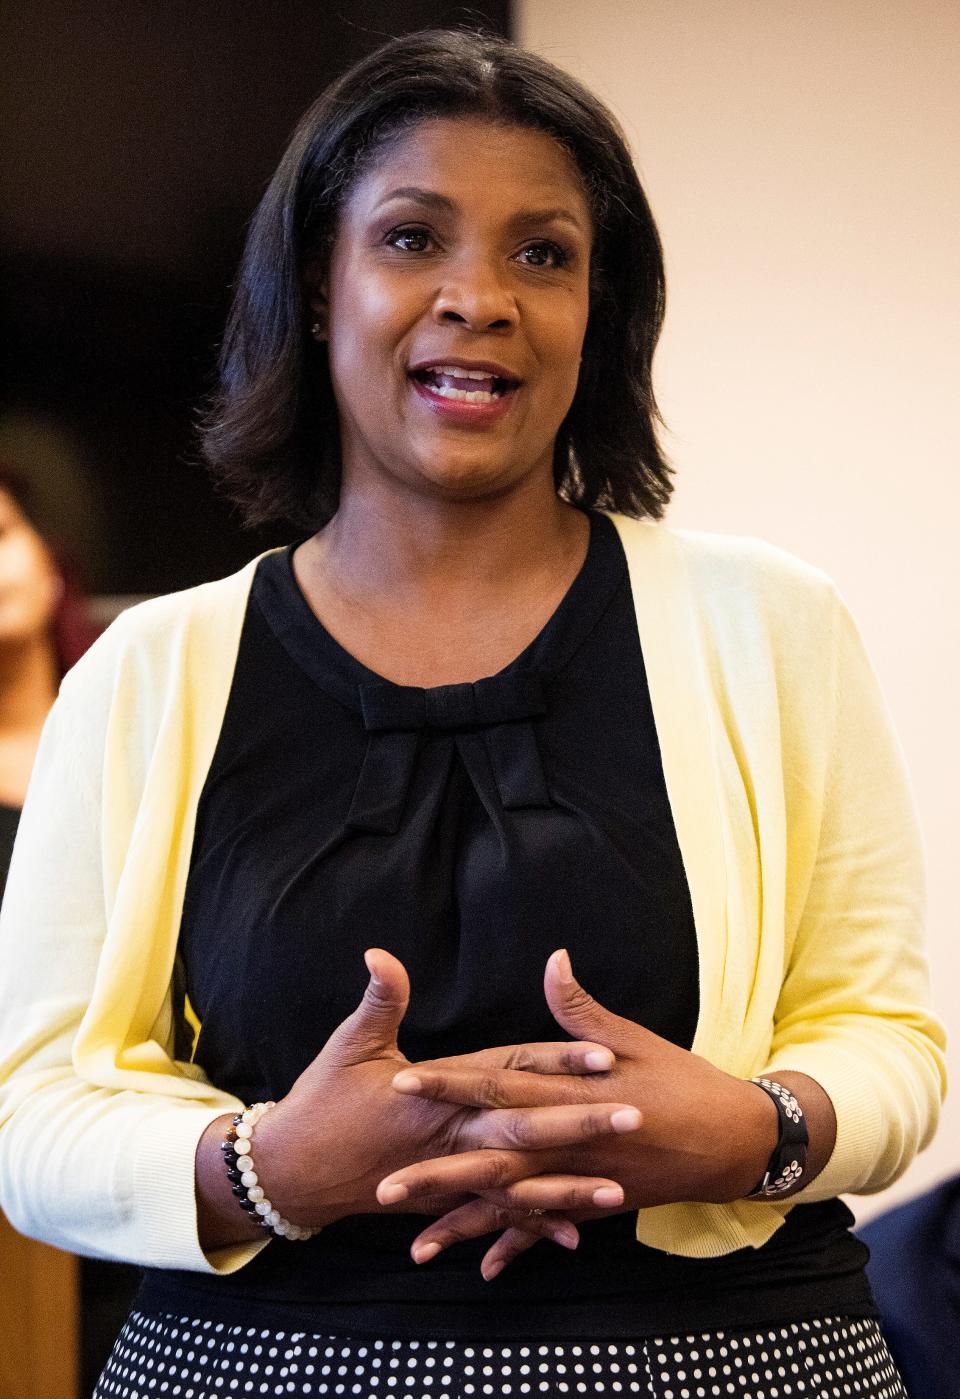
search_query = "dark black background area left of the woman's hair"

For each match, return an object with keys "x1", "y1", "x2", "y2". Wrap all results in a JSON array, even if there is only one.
[{"x1": 0, "y1": 0, "x2": 509, "y2": 593}]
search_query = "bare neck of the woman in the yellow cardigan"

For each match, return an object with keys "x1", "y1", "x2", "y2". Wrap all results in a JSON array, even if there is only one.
[{"x1": 311, "y1": 480, "x2": 586, "y2": 604}]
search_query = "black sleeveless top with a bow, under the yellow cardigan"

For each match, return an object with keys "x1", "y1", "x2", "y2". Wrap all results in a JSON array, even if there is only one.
[{"x1": 141, "y1": 515, "x2": 872, "y2": 1337}]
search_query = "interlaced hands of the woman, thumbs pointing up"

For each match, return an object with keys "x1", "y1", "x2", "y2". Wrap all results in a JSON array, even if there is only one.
[{"x1": 257, "y1": 949, "x2": 777, "y2": 1279}]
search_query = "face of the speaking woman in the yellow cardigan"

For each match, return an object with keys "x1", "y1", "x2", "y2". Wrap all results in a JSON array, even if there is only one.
[{"x1": 311, "y1": 119, "x2": 592, "y2": 499}]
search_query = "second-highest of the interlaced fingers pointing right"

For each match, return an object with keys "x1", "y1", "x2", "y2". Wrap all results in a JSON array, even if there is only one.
[{"x1": 455, "y1": 1102, "x2": 642, "y2": 1151}]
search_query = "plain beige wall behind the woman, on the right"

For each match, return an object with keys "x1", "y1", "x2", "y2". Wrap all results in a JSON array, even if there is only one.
[{"x1": 516, "y1": 0, "x2": 960, "y2": 1214}]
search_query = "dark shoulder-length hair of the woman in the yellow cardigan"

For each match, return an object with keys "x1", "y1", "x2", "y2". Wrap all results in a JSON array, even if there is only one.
[{"x1": 203, "y1": 29, "x2": 672, "y2": 530}]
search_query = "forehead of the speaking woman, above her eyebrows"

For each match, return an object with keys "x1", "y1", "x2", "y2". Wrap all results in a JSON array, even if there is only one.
[{"x1": 347, "y1": 118, "x2": 591, "y2": 232}]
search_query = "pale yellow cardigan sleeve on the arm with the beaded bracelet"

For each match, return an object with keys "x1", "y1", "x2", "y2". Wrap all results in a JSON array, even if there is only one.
[{"x1": 0, "y1": 623, "x2": 263, "y2": 1272}]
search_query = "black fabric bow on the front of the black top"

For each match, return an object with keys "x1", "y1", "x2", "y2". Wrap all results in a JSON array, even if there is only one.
[{"x1": 347, "y1": 670, "x2": 550, "y2": 835}]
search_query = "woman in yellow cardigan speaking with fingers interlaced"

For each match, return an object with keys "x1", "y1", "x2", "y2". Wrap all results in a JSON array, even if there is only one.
[{"x1": 0, "y1": 34, "x2": 943, "y2": 1399}]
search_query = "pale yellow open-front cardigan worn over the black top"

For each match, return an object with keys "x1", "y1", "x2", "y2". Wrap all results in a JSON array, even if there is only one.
[{"x1": 0, "y1": 516, "x2": 943, "y2": 1272}]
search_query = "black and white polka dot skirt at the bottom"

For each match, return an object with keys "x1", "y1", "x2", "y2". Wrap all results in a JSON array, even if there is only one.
[{"x1": 94, "y1": 1311, "x2": 907, "y2": 1399}]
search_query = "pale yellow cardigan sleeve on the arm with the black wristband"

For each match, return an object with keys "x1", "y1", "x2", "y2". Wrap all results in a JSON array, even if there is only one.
[{"x1": 764, "y1": 590, "x2": 945, "y2": 1200}]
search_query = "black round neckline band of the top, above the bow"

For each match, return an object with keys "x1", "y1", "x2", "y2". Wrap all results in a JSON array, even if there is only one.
[{"x1": 250, "y1": 512, "x2": 627, "y2": 711}]
